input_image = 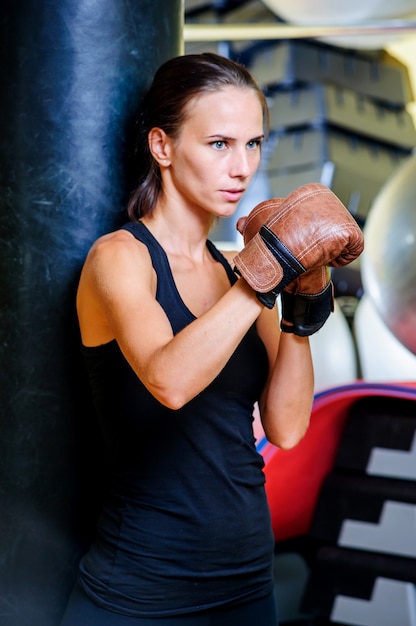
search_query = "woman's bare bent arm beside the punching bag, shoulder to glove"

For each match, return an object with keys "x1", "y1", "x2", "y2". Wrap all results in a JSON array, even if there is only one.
[{"x1": 77, "y1": 232, "x2": 263, "y2": 409}]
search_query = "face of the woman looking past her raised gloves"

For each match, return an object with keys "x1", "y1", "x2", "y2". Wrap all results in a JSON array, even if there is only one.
[{"x1": 164, "y1": 87, "x2": 264, "y2": 217}]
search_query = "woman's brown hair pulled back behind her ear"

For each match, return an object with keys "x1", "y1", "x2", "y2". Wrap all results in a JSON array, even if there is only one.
[{"x1": 127, "y1": 52, "x2": 269, "y2": 221}]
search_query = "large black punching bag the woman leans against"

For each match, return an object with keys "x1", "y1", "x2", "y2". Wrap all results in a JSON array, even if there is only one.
[{"x1": 0, "y1": 0, "x2": 183, "y2": 626}]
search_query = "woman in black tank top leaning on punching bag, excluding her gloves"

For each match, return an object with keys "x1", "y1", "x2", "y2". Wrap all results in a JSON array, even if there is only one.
[{"x1": 62, "y1": 53, "x2": 313, "y2": 626}]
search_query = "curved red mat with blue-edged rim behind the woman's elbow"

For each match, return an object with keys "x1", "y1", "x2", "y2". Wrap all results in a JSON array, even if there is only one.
[{"x1": 255, "y1": 381, "x2": 416, "y2": 541}]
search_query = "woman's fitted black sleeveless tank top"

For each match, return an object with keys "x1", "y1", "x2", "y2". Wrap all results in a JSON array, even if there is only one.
[{"x1": 80, "y1": 222, "x2": 274, "y2": 617}]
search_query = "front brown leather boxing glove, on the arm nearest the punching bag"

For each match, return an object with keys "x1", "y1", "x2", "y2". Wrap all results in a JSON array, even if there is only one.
[{"x1": 234, "y1": 183, "x2": 364, "y2": 308}]
